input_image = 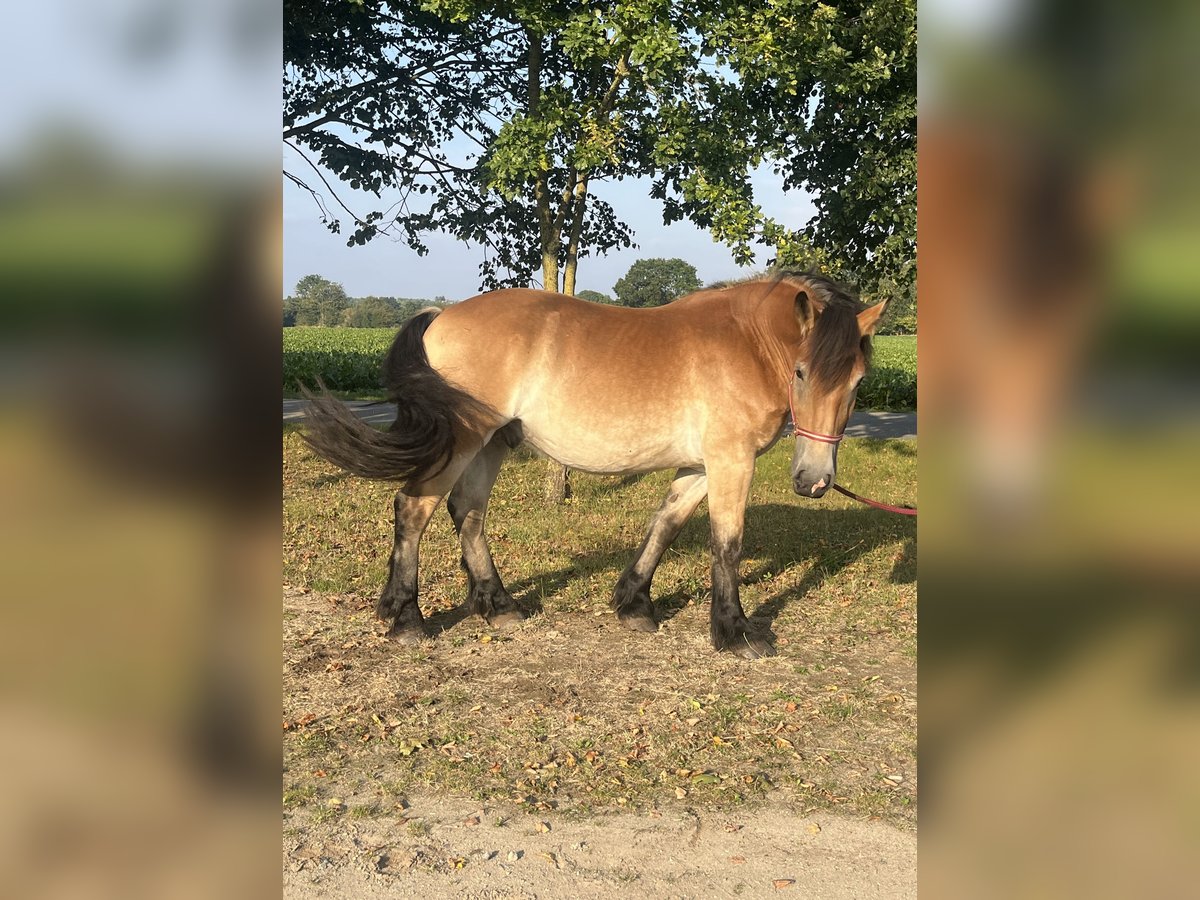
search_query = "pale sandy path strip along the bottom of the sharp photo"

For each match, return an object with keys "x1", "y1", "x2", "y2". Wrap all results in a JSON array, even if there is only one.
[{"x1": 283, "y1": 796, "x2": 917, "y2": 900}]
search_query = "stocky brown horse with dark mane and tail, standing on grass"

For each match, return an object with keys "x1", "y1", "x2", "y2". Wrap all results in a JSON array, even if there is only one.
[{"x1": 306, "y1": 274, "x2": 886, "y2": 659}]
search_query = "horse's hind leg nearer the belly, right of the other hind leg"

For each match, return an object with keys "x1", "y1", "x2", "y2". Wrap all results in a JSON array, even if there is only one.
[{"x1": 446, "y1": 431, "x2": 526, "y2": 628}]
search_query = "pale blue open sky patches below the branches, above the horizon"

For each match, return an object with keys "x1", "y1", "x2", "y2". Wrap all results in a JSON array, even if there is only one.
[{"x1": 283, "y1": 149, "x2": 816, "y2": 300}]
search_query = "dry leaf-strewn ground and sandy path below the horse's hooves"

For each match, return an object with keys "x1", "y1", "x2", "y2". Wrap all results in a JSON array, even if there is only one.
[{"x1": 282, "y1": 580, "x2": 916, "y2": 900}]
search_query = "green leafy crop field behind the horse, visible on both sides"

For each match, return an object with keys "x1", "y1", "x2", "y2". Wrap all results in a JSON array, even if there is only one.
[{"x1": 283, "y1": 325, "x2": 917, "y2": 410}]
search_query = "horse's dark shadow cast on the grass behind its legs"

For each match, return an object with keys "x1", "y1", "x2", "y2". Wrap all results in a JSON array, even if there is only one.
[{"x1": 441, "y1": 503, "x2": 917, "y2": 630}]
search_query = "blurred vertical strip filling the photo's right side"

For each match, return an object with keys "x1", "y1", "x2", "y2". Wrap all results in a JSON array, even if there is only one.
[{"x1": 918, "y1": 0, "x2": 1200, "y2": 898}]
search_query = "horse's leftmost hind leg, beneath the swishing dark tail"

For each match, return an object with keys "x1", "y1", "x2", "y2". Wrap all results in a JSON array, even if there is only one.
[{"x1": 376, "y1": 455, "x2": 473, "y2": 643}]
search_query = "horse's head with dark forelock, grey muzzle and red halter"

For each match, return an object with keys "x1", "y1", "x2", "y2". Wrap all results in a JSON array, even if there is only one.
[{"x1": 791, "y1": 288, "x2": 887, "y2": 497}]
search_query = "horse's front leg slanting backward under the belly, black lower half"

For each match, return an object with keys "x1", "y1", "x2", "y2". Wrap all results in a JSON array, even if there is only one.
[{"x1": 612, "y1": 469, "x2": 708, "y2": 631}]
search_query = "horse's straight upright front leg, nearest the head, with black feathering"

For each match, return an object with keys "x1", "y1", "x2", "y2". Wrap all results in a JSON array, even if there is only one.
[{"x1": 708, "y1": 456, "x2": 775, "y2": 659}]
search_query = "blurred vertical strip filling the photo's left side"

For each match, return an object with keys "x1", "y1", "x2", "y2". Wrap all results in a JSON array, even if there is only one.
[{"x1": 0, "y1": 0, "x2": 282, "y2": 896}]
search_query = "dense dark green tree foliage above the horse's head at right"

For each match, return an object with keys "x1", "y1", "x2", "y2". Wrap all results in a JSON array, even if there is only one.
[{"x1": 731, "y1": 0, "x2": 917, "y2": 316}]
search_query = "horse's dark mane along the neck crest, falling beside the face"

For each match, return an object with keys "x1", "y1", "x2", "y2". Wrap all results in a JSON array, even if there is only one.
[{"x1": 707, "y1": 269, "x2": 871, "y2": 389}]
